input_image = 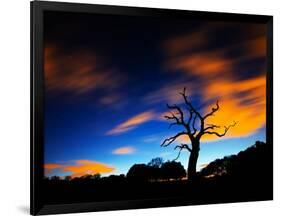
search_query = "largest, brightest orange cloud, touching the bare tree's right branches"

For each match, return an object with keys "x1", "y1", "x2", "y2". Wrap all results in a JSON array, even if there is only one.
[{"x1": 199, "y1": 76, "x2": 266, "y2": 140}]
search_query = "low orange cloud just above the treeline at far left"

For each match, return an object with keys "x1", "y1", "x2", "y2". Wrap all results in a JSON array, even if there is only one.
[{"x1": 44, "y1": 160, "x2": 115, "y2": 178}]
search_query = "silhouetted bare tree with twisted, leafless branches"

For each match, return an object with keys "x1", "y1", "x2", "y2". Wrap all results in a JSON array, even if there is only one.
[{"x1": 161, "y1": 88, "x2": 236, "y2": 180}]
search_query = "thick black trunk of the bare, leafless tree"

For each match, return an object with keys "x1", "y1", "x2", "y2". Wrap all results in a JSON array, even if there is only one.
[{"x1": 187, "y1": 142, "x2": 200, "y2": 181}]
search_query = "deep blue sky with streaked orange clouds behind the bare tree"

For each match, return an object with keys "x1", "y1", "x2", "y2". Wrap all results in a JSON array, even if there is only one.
[{"x1": 44, "y1": 12, "x2": 266, "y2": 177}]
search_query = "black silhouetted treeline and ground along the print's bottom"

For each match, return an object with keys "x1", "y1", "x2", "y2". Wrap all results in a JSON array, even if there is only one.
[{"x1": 44, "y1": 141, "x2": 273, "y2": 204}]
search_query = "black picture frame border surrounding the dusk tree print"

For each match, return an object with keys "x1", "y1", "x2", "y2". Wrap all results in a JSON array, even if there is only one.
[{"x1": 30, "y1": 1, "x2": 273, "y2": 215}]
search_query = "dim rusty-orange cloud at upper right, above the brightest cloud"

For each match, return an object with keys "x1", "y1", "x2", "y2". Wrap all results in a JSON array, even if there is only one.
[{"x1": 163, "y1": 22, "x2": 266, "y2": 78}]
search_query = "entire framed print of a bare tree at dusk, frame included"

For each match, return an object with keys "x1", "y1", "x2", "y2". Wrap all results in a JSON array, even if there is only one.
[{"x1": 31, "y1": 1, "x2": 273, "y2": 215}]
